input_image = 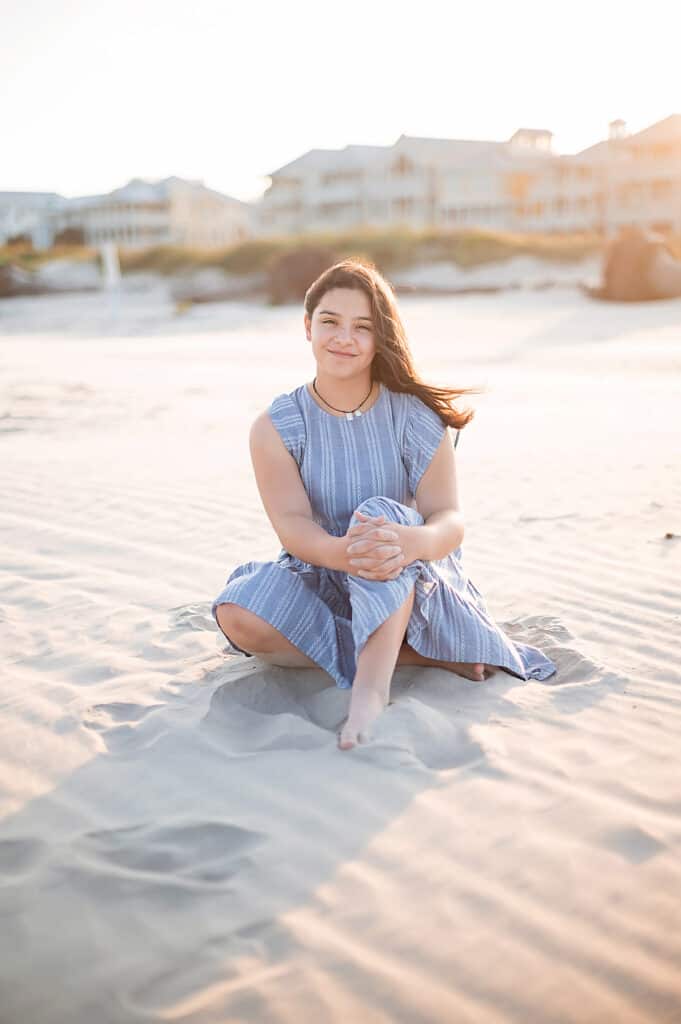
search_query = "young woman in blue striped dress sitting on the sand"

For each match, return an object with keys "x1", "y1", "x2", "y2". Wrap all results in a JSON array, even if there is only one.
[{"x1": 212, "y1": 259, "x2": 556, "y2": 750}]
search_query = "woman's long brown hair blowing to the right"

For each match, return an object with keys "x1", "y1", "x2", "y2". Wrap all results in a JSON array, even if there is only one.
[{"x1": 305, "y1": 256, "x2": 480, "y2": 430}]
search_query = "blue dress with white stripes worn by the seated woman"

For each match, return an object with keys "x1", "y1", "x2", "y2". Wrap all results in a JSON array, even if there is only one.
[{"x1": 211, "y1": 384, "x2": 556, "y2": 689}]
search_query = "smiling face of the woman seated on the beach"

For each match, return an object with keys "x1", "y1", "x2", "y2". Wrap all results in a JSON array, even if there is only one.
[{"x1": 305, "y1": 288, "x2": 376, "y2": 377}]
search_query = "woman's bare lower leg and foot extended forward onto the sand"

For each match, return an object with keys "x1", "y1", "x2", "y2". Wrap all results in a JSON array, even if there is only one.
[{"x1": 338, "y1": 589, "x2": 414, "y2": 751}]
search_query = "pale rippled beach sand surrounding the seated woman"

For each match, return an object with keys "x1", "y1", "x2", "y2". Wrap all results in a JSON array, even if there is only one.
[{"x1": 0, "y1": 291, "x2": 681, "y2": 1024}]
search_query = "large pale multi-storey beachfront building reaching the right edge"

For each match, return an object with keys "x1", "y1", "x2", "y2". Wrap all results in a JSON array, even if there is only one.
[{"x1": 257, "y1": 115, "x2": 681, "y2": 236}]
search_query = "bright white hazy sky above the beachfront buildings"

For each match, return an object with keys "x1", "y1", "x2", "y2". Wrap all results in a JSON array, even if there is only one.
[{"x1": 0, "y1": 0, "x2": 681, "y2": 199}]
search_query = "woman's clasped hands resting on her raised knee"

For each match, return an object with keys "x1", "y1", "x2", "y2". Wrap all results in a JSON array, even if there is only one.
[{"x1": 345, "y1": 512, "x2": 414, "y2": 580}]
